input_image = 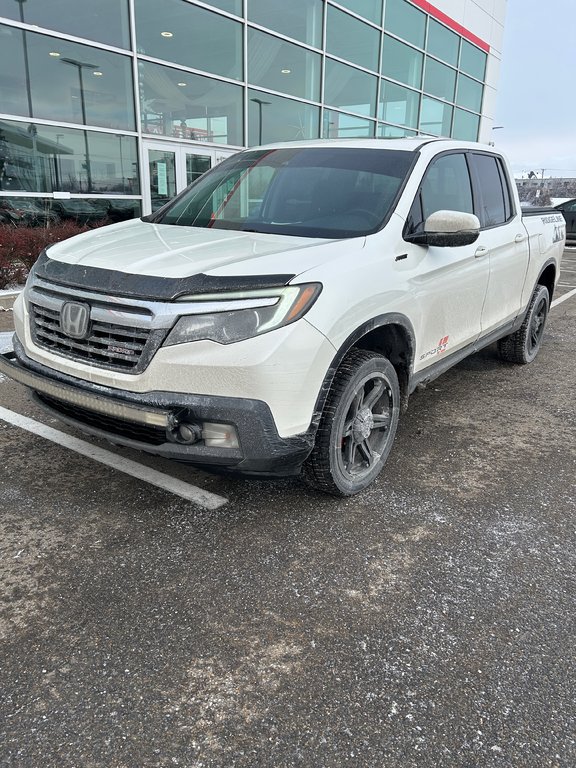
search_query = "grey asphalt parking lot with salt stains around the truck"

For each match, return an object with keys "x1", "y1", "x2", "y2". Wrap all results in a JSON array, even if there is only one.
[{"x1": 0, "y1": 254, "x2": 576, "y2": 768}]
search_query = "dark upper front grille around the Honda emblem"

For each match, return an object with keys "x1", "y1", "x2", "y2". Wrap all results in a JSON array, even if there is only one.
[{"x1": 30, "y1": 302, "x2": 166, "y2": 373}]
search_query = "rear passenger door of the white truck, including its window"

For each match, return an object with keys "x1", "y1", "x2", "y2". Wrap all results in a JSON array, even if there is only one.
[{"x1": 469, "y1": 152, "x2": 530, "y2": 336}]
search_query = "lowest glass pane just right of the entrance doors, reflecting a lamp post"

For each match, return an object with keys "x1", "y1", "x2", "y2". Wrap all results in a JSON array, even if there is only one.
[{"x1": 248, "y1": 91, "x2": 320, "y2": 146}]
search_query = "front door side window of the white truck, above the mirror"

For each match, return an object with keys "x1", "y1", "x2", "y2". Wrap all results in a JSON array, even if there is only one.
[{"x1": 409, "y1": 154, "x2": 474, "y2": 230}]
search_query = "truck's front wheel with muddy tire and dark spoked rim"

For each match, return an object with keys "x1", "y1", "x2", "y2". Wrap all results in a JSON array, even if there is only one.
[{"x1": 303, "y1": 349, "x2": 400, "y2": 496}]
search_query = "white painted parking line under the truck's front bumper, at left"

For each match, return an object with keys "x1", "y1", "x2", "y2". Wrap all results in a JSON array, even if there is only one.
[{"x1": 0, "y1": 406, "x2": 228, "y2": 509}]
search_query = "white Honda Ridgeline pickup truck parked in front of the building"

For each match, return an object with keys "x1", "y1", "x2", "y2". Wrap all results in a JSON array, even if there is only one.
[{"x1": 0, "y1": 137, "x2": 565, "y2": 496}]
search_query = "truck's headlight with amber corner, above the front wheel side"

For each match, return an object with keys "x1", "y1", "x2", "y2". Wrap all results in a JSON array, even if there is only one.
[{"x1": 164, "y1": 283, "x2": 322, "y2": 346}]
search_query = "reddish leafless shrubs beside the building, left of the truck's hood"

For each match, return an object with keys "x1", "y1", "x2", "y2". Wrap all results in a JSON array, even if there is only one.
[{"x1": 0, "y1": 221, "x2": 107, "y2": 290}]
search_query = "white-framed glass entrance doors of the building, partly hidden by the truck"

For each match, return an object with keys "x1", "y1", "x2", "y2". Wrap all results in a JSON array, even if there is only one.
[{"x1": 143, "y1": 141, "x2": 234, "y2": 214}]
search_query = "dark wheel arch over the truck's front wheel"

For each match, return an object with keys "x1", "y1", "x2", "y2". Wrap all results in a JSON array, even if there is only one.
[{"x1": 312, "y1": 313, "x2": 416, "y2": 427}]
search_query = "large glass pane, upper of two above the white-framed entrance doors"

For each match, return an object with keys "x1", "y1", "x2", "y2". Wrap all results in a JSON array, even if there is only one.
[{"x1": 136, "y1": 0, "x2": 242, "y2": 80}]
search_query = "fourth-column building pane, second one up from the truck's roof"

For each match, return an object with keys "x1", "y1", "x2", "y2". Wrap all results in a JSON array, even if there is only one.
[{"x1": 324, "y1": 59, "x2": 378, "y2": 116}]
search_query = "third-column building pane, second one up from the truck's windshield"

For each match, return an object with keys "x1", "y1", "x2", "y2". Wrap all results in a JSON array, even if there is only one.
[{"x1": 248, "y1": 29, "x2": 320, "y2": 101}]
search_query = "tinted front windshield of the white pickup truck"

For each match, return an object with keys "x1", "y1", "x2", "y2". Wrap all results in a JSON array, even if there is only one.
[{"x1": 147, "y1": 146, "x2": 415, "y2": 238}]
